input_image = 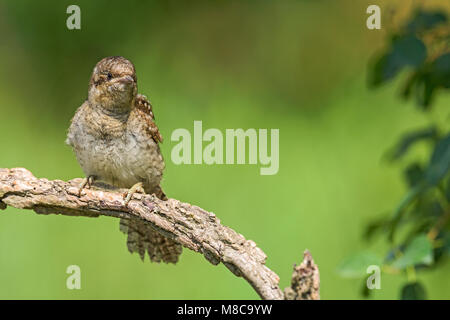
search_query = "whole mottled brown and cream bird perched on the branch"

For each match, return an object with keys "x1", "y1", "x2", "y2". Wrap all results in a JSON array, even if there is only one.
[{"x1": 66, "y1": 56, "x2": 182, "y2": 263}]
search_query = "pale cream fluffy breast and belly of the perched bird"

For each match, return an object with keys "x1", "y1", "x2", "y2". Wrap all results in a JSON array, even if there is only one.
[{"x1": 69, "y1": 114, "x2": 164, "y2": 190}]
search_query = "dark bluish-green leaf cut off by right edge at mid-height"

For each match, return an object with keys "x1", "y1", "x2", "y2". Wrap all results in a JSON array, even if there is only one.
[{"x1": 425, "y1": 134, "x2": 450, "y2": 186}]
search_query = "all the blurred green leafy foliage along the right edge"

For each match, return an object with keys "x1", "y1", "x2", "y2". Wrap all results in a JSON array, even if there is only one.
[{"x1": 338, "y1": 5, "x2": 450, "y2": 300}]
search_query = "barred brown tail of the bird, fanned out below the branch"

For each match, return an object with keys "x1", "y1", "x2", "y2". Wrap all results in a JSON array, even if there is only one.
[{"x1": 120, "y1": 188, "x2": 182, "y2": 263}]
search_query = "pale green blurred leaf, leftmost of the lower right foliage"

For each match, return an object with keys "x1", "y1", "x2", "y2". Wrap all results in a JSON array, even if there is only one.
[{"x1": 337, "y1": 251, "x2": 383, "y2": 278}]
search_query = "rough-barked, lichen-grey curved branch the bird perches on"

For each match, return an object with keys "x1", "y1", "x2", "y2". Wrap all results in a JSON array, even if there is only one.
[{"x1": 0, "y1": 168, "x2": 319, "y2": 300}]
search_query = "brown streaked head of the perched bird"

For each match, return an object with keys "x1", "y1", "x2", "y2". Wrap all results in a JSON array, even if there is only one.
[{"x1": 88, "y1": 56, "x2": 137, "y2": 112}]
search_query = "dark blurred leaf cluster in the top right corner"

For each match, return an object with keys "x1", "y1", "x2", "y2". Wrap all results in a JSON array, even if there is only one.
[{"x1": 369, "y1": 10, "x2": 450, "y2": 109}]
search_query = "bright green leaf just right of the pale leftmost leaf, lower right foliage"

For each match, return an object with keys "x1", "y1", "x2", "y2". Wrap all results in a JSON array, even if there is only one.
[{"x1": 392, "y1": 234, "x2": 433, "y2": 269}]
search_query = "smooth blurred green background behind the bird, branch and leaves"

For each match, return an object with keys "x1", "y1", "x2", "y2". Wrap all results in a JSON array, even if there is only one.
[{"x1": 0, "y1": 0, "x2": 450, "y2": 299}]
